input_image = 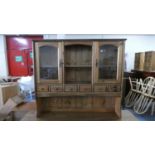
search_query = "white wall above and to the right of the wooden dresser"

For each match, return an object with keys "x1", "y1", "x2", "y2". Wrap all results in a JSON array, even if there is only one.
[{"x1": 44, "y1": 34, "x2": 155, "y2": 71}]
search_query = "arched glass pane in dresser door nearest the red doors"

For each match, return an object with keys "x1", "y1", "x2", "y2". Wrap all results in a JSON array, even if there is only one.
[{"x1": 39, "y1": 46, "x2": 58, "y2": 80}]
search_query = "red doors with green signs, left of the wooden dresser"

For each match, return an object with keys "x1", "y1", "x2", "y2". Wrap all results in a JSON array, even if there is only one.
[{"x1": 6, "y1": 36, "x2": 43, "y2": 76}]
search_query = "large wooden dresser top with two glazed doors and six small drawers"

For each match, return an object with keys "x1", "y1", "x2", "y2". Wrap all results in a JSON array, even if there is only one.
[{"x1": 33, "y1": 39, "x2": 126, "y2": 119}]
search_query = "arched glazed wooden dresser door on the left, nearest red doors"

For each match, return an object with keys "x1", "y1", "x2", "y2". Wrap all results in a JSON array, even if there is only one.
[{"x1": 35, "y1": 42, "x2": 62, "y2": 83}]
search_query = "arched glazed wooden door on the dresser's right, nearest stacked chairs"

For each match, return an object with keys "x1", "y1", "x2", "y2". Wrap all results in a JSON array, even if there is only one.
[{"x1": 94, "y1": 41, "x2": 123, "y2": 83}]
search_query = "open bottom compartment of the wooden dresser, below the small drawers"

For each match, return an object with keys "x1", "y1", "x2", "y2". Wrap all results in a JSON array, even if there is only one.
[{"x1": 37, "y1": 96, "x2": 121, "y2": 120}]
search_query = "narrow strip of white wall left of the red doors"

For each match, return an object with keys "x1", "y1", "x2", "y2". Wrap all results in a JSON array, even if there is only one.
[{"x1": 0, "y1": 35, "x2": 8, "y2": 77}]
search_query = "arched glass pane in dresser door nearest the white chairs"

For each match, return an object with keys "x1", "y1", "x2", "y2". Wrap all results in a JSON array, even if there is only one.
[{"x1": 99, "y1": 45, "x2": 117, "y2": 79}]
